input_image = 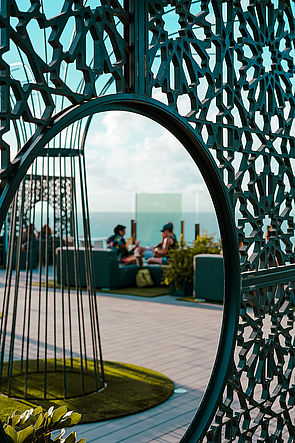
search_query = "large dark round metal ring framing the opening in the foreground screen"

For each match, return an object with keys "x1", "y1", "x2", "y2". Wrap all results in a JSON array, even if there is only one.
[{"x1": 0, "y1": 94, "x2": 240, "y2": 442}]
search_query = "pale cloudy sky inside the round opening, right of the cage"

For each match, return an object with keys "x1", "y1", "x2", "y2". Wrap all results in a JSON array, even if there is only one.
[{"x1": 86, "y1": 111, "x2": 212, "y2": 211}]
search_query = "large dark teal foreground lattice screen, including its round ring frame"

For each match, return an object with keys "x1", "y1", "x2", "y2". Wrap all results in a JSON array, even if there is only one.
[{"x1": 0, "y1": 0, "x2": 295, "y2": 442}]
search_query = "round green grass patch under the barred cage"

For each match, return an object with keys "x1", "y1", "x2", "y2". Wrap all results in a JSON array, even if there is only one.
[{"x1": 0, "y1": 359, "x2": 174, "y2": 423}]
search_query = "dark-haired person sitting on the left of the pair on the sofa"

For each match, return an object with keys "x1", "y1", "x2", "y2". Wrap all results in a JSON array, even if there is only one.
[{"x1": 107, "y1": 225, "x2": 142, "y2": 266}]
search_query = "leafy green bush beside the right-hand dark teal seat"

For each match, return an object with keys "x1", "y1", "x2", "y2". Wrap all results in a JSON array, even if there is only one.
[{"x1": 163, "y1": 232, "x2": 221, "y2": 297}]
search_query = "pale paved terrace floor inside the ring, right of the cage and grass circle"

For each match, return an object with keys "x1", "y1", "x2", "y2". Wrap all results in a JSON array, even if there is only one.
[{"x1": 76, "y1": 295, "x2": 223, "y2": 443}]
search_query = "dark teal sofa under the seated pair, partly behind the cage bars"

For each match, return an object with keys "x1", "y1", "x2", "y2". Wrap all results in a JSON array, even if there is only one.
[{"x1": 56, "y1": 247, "x2": 162, "y2": 288}]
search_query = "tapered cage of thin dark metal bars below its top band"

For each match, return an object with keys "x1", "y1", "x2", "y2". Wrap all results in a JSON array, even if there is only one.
[{"x1": 0, "y1": 134, "x2": 105, "y2": 399}]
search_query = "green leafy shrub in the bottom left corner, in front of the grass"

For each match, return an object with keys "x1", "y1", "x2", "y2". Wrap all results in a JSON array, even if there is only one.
[{"x1": 3, "y1": 406, "x2": 86, "y2": 443}]
